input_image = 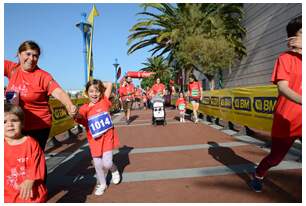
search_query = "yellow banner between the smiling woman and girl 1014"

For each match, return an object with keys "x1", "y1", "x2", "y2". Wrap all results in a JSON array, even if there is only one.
[{"x1": 49, "y1": 98, "x2": 88, "y2": 137}]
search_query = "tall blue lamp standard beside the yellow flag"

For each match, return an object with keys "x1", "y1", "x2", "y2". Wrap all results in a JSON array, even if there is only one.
[{"x1": 75, "y1": 13, "x2": 91, "y2": 85}]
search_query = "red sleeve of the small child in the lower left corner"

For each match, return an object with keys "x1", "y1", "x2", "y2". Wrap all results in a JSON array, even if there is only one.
[{"x1": 27, "y1": 137, "x2": 46, "y2": 180}]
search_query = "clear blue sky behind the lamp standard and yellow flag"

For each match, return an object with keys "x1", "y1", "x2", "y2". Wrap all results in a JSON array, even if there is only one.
[{"x1": 4, "y1": 3, "x2": 158, "y2": 90}]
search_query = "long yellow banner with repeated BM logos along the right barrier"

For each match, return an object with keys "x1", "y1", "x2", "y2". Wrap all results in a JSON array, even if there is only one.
[{"x1": 172, "y1": 85, "x2": 278, "y2": 131}]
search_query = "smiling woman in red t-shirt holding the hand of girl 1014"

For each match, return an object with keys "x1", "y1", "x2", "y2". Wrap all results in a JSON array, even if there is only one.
[{"x1": 4, "y1": 41, "x2": 77, "y2": 150}]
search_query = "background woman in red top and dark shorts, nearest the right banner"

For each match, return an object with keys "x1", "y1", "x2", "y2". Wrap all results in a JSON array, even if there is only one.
[{"x1": 188, "y1": 75, "x2": 202, "y2": 123}]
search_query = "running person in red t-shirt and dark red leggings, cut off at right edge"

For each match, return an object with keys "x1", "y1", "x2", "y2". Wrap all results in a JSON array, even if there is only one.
[{"x1": 250, "y1": 16, "x2": 302, "y2": 192}]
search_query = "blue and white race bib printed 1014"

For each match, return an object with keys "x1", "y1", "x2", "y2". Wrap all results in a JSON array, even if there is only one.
[{"x1": 88, "y1": 112, "x2": 113, "y2": 139}]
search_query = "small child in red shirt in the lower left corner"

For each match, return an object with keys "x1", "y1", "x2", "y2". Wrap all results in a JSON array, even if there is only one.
[{"x1": 4, "y1": 104, "x2": 47, "y2": 203}]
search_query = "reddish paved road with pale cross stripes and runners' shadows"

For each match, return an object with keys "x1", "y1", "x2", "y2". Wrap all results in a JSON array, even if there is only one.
[{"x1": 46, "y1": 109, "x2": 302, "y2": 203}]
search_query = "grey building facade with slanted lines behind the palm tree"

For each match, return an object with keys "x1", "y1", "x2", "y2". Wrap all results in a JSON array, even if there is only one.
[{"x1": 221, "y1": 3, "x2": 302, "y2": 89}]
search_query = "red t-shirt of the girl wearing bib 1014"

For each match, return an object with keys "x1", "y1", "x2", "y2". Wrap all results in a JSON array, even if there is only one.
[{"x1": 76, "y1": 97, "x2": 119, "y2": 157}]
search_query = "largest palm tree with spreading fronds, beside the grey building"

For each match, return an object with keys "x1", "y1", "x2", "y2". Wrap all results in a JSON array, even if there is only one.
[{"x1": 128, "y1": 3, "x2": 246, "y2": 89}]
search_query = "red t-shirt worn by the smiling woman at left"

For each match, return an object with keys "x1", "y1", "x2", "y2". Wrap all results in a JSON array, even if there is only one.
[{"x1": 4, "y1": 60, "x2": 60, "y2": 131}]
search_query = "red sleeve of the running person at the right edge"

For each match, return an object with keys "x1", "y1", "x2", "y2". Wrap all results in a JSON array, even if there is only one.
[{"x1": 271, "y1": 55, "x2": 292, "y2": 84}]
